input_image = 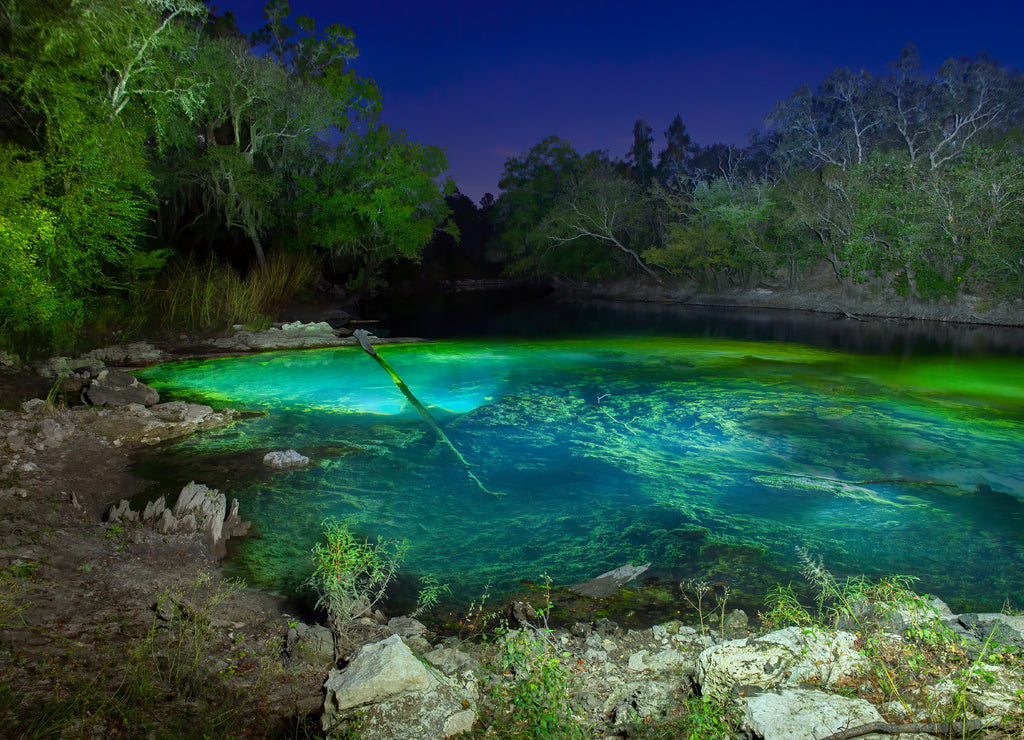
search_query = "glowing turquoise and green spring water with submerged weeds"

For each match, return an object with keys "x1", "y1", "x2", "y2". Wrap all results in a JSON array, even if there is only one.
[{"x1": 143, "y1": 339, "x2": 1024, "y2": 608}]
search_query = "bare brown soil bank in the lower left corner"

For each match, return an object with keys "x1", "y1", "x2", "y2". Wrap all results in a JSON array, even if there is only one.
[{"x1": 0, "y1": 372, "x2": 329, "y2": 738}]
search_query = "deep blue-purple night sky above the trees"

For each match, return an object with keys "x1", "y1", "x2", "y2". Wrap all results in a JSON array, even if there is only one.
[{"x1": 215, "y1": 0, "x2": 1024, "y2": 201}]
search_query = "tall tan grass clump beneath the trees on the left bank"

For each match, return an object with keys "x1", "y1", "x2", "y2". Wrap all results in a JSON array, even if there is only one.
[{"x1": 154, "y1": 252, "x2": 319, "y2": 331}]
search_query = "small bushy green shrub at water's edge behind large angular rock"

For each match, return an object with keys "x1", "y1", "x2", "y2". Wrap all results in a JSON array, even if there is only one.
[{"x1": 307, "y1": 520, "x2": 409, "y2": 635}]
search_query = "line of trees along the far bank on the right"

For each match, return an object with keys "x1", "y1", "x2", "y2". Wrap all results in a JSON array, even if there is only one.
[{"x1": 493, "y1": 46, "x2": 1024, "y2": 300}]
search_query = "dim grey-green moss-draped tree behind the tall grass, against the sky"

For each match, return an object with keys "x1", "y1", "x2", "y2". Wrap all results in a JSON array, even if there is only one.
[{"x1": 161, "y1": 0, "x2": 380, "y2": 266}]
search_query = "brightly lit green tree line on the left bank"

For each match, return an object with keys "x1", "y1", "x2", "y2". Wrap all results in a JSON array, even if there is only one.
[{"x1": 0, "y1": 0, "x2": 449, "y2": 344}]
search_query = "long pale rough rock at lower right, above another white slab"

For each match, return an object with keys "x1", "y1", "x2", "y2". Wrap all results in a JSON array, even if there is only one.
[{"x1": 696, "y1": 627, "x2": 866, "y2": 700}]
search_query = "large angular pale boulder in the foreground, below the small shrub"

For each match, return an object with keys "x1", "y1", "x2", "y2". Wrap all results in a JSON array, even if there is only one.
[{"x1": 322, "y1": 635, "x2": 476, "y2": 740}]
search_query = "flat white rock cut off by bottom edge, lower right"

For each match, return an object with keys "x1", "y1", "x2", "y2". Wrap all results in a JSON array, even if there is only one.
[{"x1": 741, "y1": 689, "x2": 882, "y2": 740}]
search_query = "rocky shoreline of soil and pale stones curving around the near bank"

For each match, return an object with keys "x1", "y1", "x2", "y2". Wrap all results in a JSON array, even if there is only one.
[{"x1": 0, "y1": 324, "x2": 1024, "y2": 740}]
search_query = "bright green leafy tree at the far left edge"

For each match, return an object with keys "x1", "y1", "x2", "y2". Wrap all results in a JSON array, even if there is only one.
[{"x1": 0, "y1": 0, "x2": 205, "y2": 344}]
